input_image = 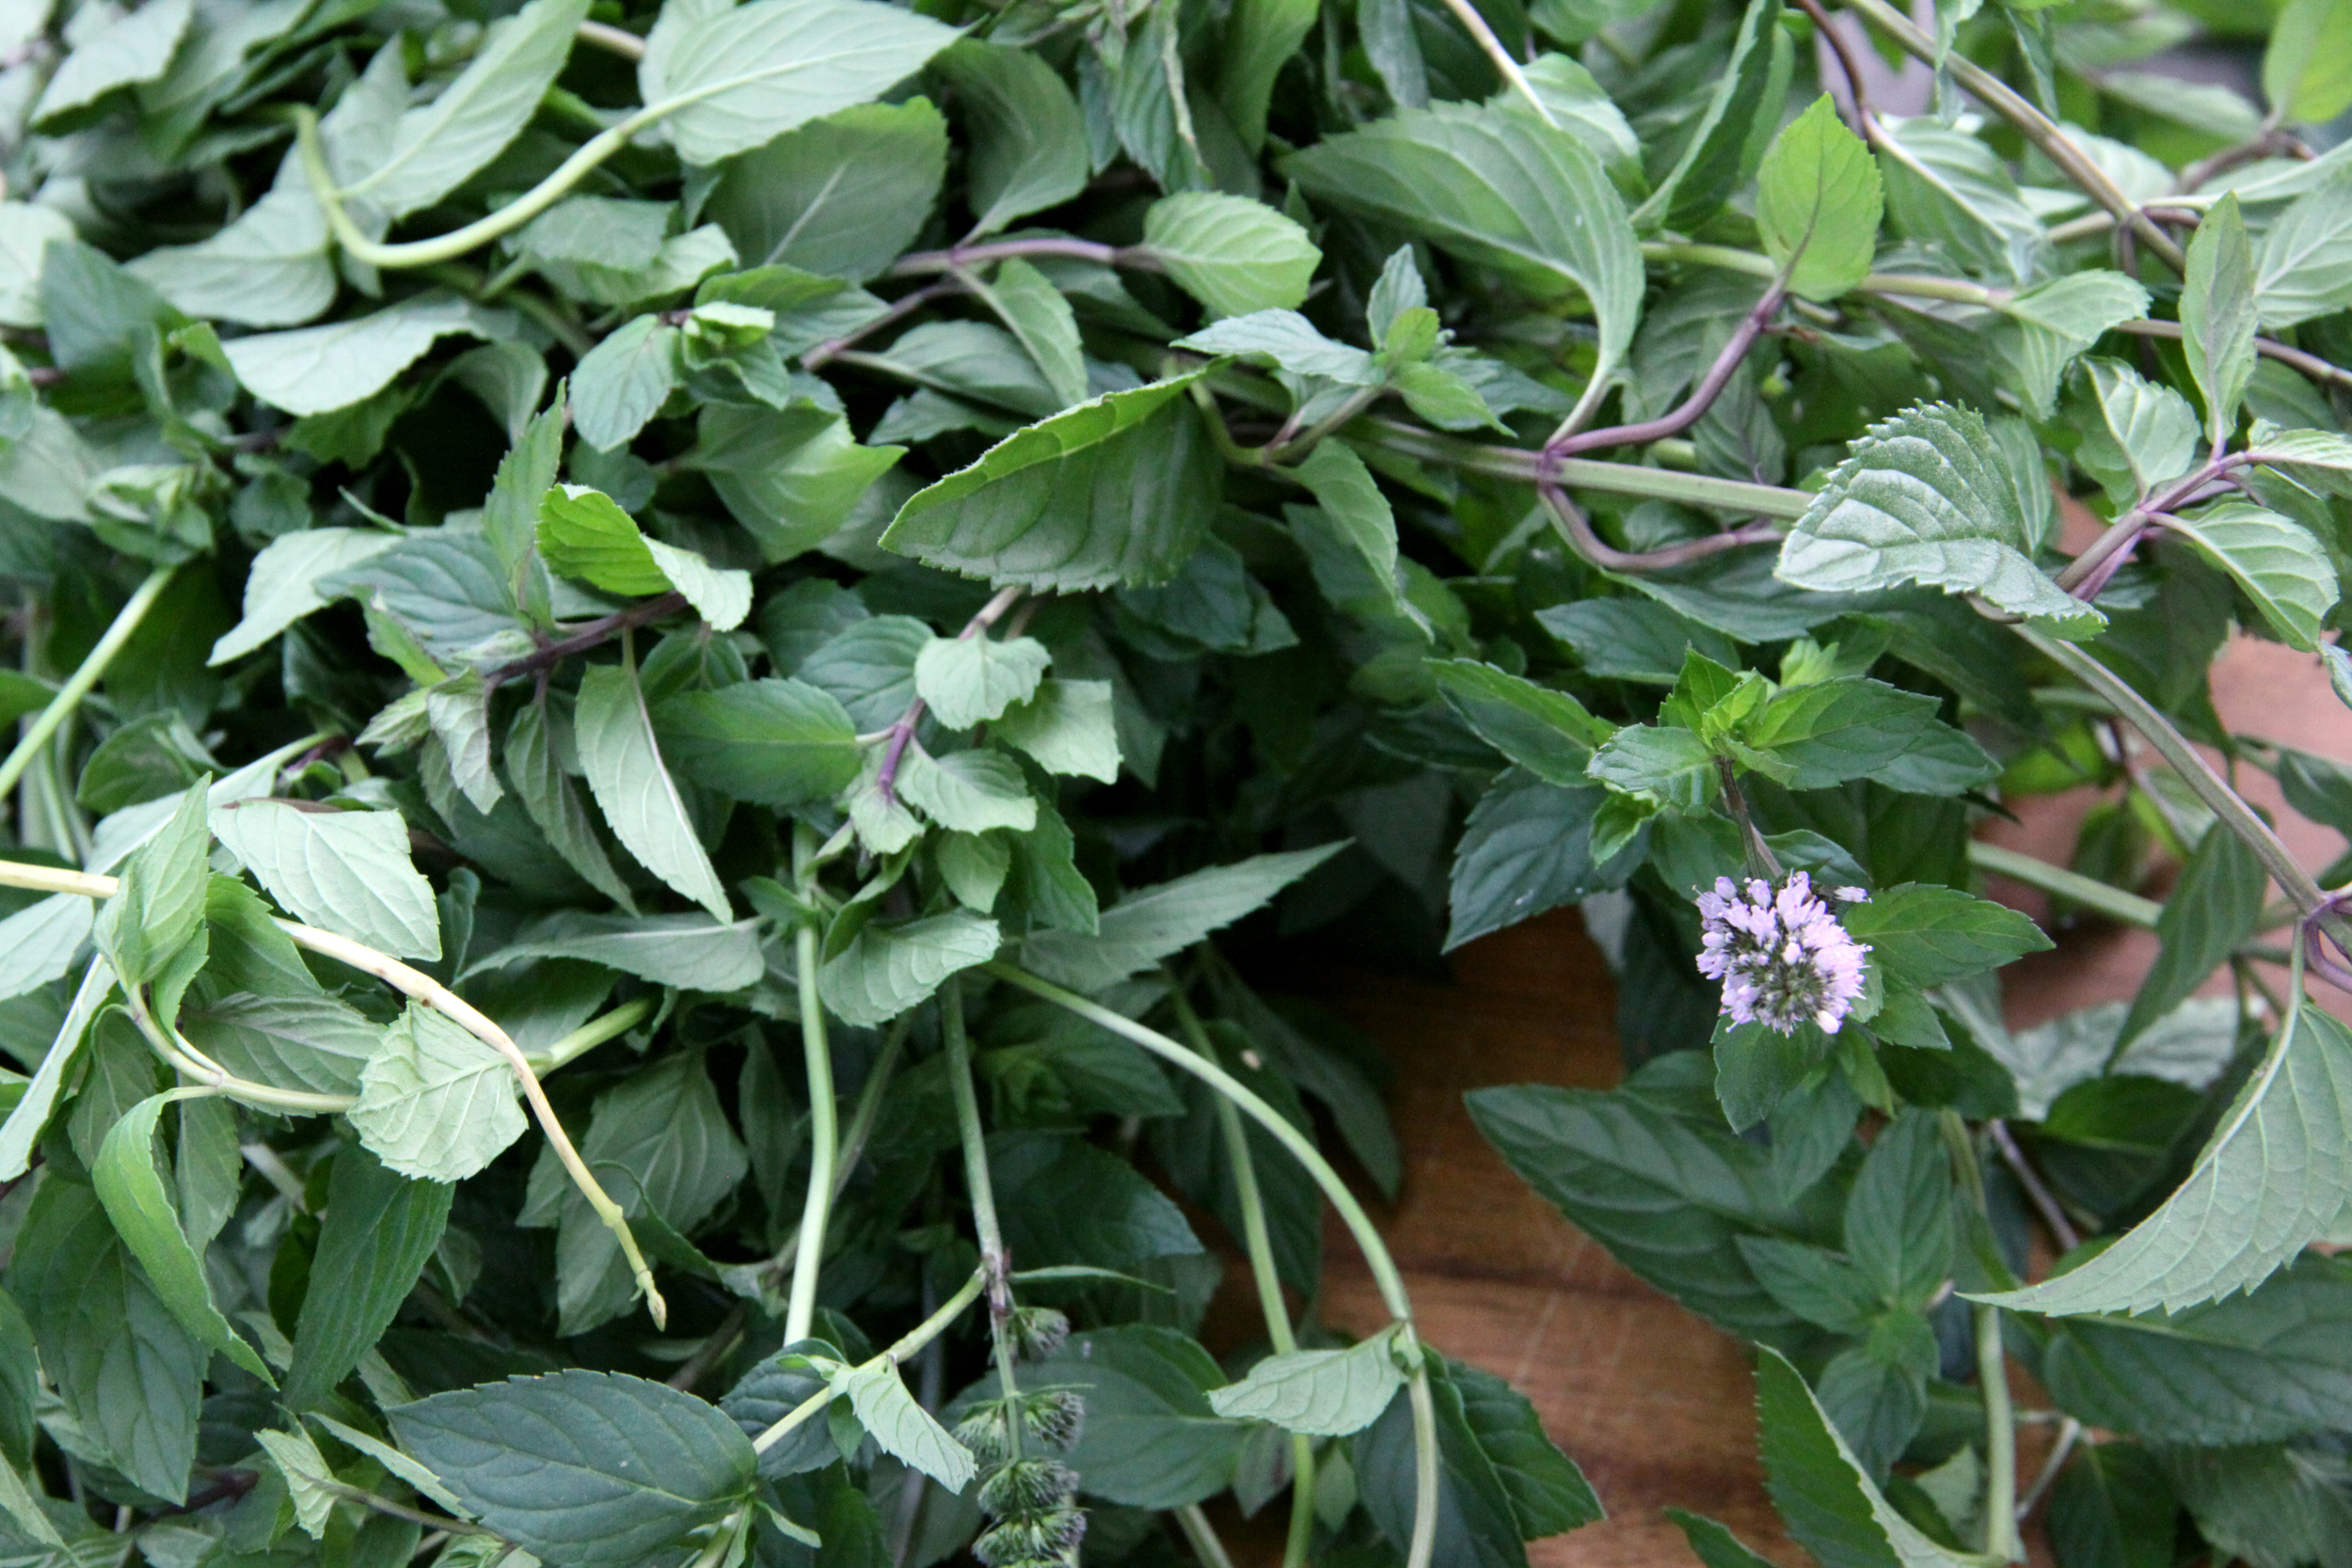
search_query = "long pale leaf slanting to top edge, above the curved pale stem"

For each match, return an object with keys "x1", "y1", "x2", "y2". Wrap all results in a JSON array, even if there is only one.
[{"x1": 343, "y1": 0, "x2": 588, "y2": 222}]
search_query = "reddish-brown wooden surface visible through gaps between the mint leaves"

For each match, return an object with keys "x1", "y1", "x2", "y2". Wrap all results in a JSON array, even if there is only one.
[{"x1": 1315, "y1": 640, "x2": 2352, "y2": 1568}]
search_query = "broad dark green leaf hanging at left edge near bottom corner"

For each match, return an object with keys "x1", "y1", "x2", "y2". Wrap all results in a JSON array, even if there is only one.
[{"x1": 8, "y1": 1180, "x2": 207, "y2": 1502}]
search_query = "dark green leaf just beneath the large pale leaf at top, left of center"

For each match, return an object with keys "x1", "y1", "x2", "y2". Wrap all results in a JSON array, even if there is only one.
[{"x1": 704, "y1": 97, "x2": 946, "y2": 282}]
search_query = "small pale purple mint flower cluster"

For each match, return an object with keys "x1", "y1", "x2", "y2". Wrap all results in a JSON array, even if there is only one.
[{"x1": 1698, "y1": 872, "x2": 1870, "y2": 1035}]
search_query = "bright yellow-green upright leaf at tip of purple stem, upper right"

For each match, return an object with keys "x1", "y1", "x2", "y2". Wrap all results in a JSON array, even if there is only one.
[{"x1": 1757, "y1": 94, "x2": 1886, "y2": 298}]
